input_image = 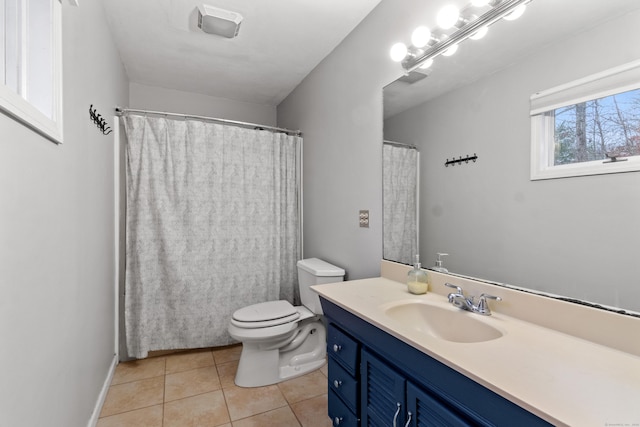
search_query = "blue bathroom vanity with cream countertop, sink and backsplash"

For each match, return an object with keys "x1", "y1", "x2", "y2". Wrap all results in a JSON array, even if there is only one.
[{"x1": 314, "y1": 266, "x2": 640, "y2": 426}]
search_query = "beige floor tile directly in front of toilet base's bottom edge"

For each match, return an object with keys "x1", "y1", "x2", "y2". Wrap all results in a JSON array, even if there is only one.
[{"x1": 223, "y1": 385, "x2": 287, "y2": 421}]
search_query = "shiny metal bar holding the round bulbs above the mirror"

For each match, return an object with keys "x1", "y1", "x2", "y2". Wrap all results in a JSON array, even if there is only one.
[{"x1": 402, "y1": 0, "x2": 531, "y2": 72}]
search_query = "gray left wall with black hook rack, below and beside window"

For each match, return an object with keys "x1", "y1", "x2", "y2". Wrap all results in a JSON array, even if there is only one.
[{"x1": 0, "y1": 1, "x2": 128, "y2": 427}]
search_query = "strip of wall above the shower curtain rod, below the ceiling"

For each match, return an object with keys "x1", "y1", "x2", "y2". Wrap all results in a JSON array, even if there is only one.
[{"x1": 128, "y1": 82, "x2": 276, "y2": 126}]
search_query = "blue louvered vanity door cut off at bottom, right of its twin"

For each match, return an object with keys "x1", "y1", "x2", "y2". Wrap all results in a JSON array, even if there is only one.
[{"x1": 407, "y1": 383, "x2": 475, "y2": 427}]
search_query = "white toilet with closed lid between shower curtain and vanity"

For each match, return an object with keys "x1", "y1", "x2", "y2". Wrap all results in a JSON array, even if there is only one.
[{"x1": 229, "y1": 258, "x2": 344, "y2": 387}]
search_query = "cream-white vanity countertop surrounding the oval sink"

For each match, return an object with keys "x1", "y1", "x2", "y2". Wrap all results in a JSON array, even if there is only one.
[{"x1": 313, "y1": 278, "x2": 640, "y2": 427}]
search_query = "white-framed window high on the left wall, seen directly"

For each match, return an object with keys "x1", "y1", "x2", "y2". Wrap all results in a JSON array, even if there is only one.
[{"x1": 0, "y1": 0, "x2": 62, "y2": 143}]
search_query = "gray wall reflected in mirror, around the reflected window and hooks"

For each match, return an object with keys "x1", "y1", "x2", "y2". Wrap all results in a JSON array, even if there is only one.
[{"x1": 385, "y1": 9, "x2": 640, "y2": 311}]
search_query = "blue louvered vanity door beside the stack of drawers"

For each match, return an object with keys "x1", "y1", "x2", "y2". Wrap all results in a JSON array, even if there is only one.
[{"x1": 360, "y1": 350, "x2": 407, "y2": 427}]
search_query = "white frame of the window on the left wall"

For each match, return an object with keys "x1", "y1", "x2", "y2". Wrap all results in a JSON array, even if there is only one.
[{"x1": 0, "y1": 0, "x2": 63, "y2": 144}]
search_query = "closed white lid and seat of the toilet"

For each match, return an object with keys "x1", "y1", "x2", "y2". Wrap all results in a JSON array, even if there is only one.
[{"x1": 232, "y1": 301, "x2": 300, "y2": 328}]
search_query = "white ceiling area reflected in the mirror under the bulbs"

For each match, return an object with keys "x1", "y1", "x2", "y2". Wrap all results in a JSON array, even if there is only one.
[{"x1": 384, "y1": 0, "x2": 640, "y2": 118}]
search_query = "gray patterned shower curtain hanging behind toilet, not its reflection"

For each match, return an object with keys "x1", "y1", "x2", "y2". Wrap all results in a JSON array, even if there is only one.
[{"x1": 124, "y1": 114, "x2": 301, "y2": 358}]
